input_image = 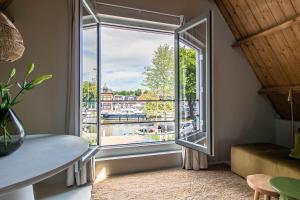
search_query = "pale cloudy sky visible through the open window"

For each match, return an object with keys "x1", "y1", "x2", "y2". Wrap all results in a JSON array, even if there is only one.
[{"x1": 83, "y1": 27, "x2": 174, "y2": 91}]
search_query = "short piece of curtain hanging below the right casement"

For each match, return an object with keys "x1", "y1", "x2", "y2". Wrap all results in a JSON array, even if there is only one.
[{"x1": 182, "y1": 147, "x2": 208, "y2": 170}]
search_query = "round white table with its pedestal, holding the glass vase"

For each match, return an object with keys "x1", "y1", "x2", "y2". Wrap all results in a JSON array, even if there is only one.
[{"x1": 0, "y1": 134, "x2": 88, "y2": 200}]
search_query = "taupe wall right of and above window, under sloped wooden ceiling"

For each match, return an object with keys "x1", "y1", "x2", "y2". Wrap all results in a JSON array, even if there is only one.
[{"x1": 98, "y1": 0, "x2": 275, "y2": 161}]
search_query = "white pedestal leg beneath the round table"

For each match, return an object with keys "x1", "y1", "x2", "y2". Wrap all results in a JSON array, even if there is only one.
[{"x1": 0, "y1": 185, "x2": 34, "y2": 200}]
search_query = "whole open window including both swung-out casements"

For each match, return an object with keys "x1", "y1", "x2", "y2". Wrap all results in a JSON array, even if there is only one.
[{"x1": 81, "y1": 0, "x2": 212, "y2": 156}]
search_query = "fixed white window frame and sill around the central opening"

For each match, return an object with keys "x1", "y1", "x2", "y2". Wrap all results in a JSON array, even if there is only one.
[{"x1": 80, "y1": 16, "x2": 181, "y2": 158}]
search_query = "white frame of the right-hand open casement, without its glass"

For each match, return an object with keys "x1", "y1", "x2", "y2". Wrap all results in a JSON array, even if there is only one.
[{"x1": 175, "y1": 11, "x2": 214, "y2": 155}]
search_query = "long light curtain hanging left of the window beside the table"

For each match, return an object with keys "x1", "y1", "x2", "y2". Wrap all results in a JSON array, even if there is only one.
[{"x1": 65, "y1": 0, "x2": 95, "y2": 186}]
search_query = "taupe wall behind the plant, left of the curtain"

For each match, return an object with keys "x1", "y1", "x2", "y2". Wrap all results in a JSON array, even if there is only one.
[{"x1": 0, "y1": 0, "x2": 68, "y2": 133}]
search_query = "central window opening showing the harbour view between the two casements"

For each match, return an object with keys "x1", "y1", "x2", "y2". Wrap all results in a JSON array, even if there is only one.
[{"x1": 100, "y1": 26, "x2": 175, "y2": 145}]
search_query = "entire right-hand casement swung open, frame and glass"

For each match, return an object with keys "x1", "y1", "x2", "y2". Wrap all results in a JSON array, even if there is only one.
[{"x1": 175, "y1": 11, "x2": 213, "y2": 155}]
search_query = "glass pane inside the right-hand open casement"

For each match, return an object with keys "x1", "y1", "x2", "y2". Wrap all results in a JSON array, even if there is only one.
[{"x1": 178, "y1": 16, "x2": 207, "y2": 148}]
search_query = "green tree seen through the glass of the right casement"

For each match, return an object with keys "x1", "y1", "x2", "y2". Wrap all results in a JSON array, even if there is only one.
[{"x1": 179, "y1": 48, "x2": 196, "y2": 119}]
